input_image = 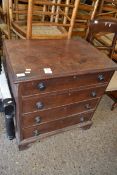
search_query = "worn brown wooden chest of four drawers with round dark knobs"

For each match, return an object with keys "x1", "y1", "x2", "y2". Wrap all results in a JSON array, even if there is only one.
[{"x1": 4, "y1": 39, "x2": 117, "y2": 148}]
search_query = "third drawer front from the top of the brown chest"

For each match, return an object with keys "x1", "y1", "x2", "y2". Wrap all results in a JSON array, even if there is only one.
[{"x1": 22, "y1": 98, "x2": 100, "y2": 128}]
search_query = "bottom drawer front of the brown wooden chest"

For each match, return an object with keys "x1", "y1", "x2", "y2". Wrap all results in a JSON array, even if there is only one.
[{"x1": 22, "y1": 112, "x2": 93, "y2": 139}]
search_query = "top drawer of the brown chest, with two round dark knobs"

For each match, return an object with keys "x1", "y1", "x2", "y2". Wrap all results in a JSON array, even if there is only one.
[{"x1": 20, "y1": 72, "x2": 113, "y2": 96}]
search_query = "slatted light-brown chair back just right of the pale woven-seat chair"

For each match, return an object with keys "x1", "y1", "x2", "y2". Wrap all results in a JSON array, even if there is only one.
[{"x1": 73, "y1": 0, "x2": 99, "y2": 38}]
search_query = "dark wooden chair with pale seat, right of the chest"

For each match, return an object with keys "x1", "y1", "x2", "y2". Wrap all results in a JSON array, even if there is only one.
[{"x1": 87, "y1": 19, "x2": 117, "y2": 110}]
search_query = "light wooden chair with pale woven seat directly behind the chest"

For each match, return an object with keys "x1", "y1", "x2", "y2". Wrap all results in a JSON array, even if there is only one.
[{"x1": 9, "y1": 0, "x2": 80, "y2": 39}]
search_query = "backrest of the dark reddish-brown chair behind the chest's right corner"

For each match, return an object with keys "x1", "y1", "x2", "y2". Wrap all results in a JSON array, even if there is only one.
[{"x1": 87, "y1": 19, "x2": 117, "y2": 59}]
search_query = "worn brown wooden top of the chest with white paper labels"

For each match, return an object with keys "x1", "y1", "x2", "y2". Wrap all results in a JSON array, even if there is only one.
[{"x1": 4, "y1": 39, "x2": 117, "y2": 83}]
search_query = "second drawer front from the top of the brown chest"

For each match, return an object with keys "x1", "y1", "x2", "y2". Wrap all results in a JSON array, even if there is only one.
[{"x1": 22, "y1": 86, "x2": 106, "y2": 113}]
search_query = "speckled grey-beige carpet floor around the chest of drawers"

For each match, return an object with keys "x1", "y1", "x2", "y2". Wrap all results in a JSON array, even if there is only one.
[{"x1": 0, "y1": 96, "x2": 117, "y2": 175}]
